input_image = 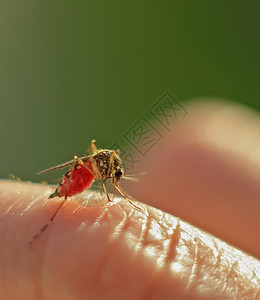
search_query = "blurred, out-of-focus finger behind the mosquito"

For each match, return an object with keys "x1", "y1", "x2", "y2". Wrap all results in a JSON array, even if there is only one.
[{"x1": 123, "y1": 101, "x2": 260, "y2": 257}]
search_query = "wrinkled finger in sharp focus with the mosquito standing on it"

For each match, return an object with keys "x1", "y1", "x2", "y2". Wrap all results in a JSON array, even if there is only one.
[{"x1": 0, "y1": 182, "x2": 260, "y2": 300}]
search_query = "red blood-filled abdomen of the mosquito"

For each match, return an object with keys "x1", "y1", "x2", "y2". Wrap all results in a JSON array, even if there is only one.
[{"x1": 50, "y1": 164, "x2": 94, "y2": 198}]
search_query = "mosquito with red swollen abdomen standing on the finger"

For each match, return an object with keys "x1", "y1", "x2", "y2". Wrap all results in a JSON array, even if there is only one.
[{"x1": 29, "y1": 140, "x2": 141, "y2": 247}]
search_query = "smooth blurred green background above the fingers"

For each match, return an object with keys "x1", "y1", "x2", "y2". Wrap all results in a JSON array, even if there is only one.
[{"x1": 0, "y1": 0, "x2": 260, "y2": 181}]
